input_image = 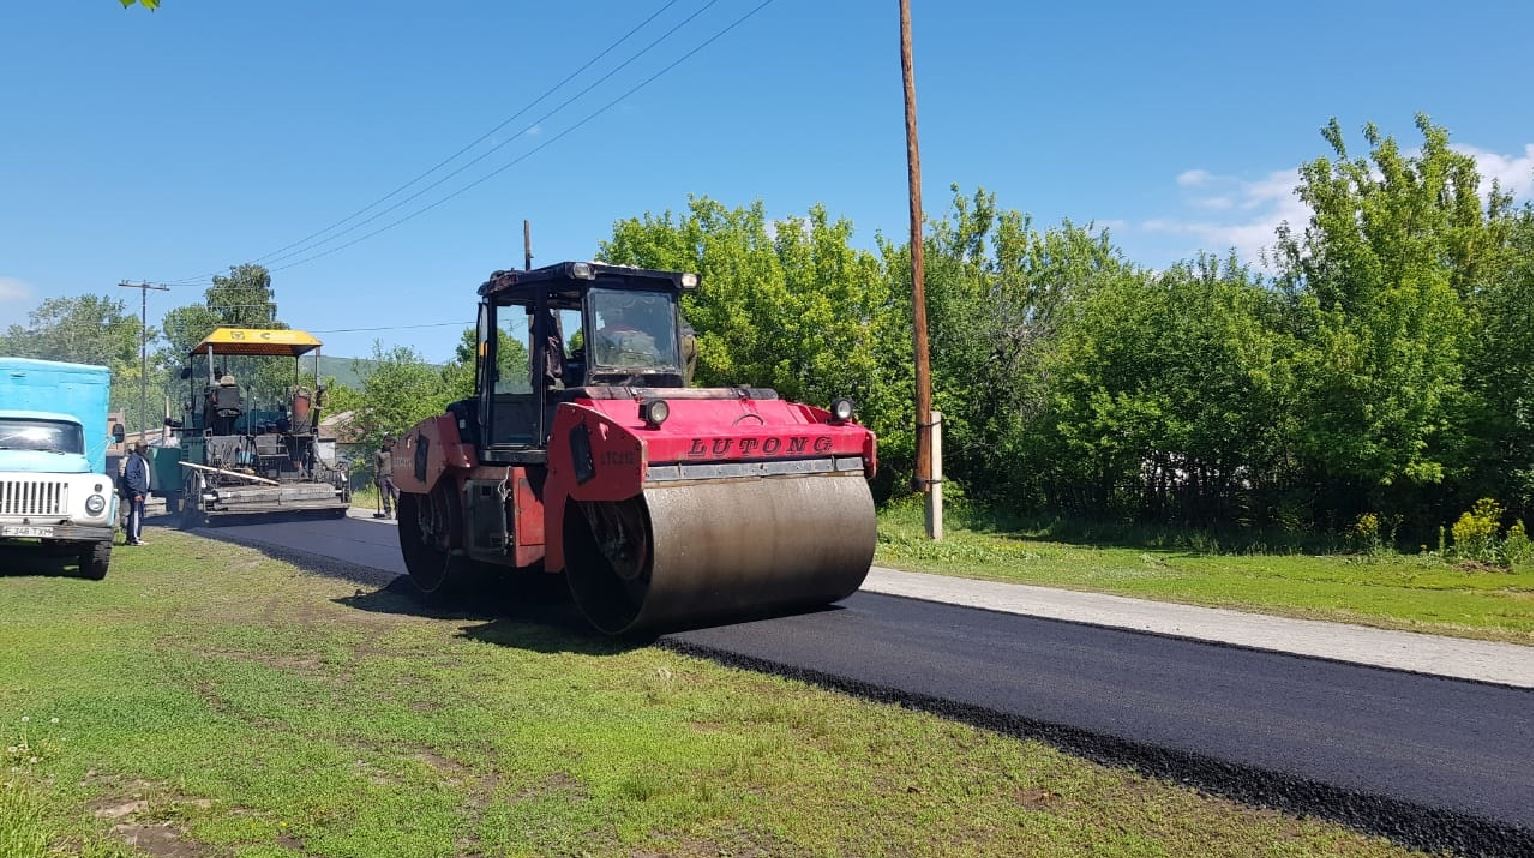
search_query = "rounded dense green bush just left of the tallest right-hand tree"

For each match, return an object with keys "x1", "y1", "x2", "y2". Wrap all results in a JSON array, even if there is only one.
[{"x1": 1037, "y1": 256, "x2": 1295, "y2": 523}]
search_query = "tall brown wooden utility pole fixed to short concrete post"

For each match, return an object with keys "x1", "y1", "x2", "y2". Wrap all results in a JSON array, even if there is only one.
[{"x1": 900, "y1": 0, "x2": 943, "y2": 539}]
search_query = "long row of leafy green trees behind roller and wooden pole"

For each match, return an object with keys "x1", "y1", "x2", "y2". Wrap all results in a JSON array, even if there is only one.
[{"x1": 600, "y1": 117, "x2": 1534, "y2": 537}]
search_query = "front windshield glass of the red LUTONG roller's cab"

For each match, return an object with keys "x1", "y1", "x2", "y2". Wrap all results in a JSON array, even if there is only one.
[{"x1": 591, "y1": 289, "x2": 681, "y2": 371}]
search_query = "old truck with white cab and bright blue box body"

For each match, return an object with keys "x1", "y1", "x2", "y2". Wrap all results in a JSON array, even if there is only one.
[{"x1": 0, "y1": 358, "x2": 123, "y2": 580}]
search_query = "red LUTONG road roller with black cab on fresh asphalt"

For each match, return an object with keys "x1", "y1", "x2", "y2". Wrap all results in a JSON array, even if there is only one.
[{"x1": 393, "y1": 262, "x2": 877, "y2": 634}]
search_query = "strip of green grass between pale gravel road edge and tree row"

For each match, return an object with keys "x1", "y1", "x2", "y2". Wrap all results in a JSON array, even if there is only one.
[{"x1": 876, "y1": 505, "x2": 1534, "y2": 645}]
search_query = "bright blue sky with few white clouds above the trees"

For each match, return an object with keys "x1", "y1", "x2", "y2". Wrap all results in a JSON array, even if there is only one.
[{"x1": 0, "y1": 0, "x2": 1534, "y2": 359}]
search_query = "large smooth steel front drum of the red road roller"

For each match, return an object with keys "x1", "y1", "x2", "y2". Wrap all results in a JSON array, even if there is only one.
[{"x1": 566, "y1": 474, "x2": 876, "y2": 634}]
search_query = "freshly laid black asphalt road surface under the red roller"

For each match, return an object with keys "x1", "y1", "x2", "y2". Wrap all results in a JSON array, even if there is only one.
[{"x1": 194, "y1": 520, "x2": 1534, "y2": 855}]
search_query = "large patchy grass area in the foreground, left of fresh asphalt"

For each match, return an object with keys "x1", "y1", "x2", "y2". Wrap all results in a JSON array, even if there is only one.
[{"x1": 0, "y1": 530, "x2": 1405, "y2": 858}]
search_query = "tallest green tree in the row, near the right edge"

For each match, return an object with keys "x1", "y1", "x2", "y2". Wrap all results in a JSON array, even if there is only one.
[{"x1": 1278, "y1": 117, "x2": 1511, "y2": 528}]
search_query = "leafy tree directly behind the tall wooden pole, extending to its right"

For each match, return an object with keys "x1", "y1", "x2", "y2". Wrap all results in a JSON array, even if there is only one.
[{"x1": 881, "y1": 186, "x2": 1132, "y2": 505}]
